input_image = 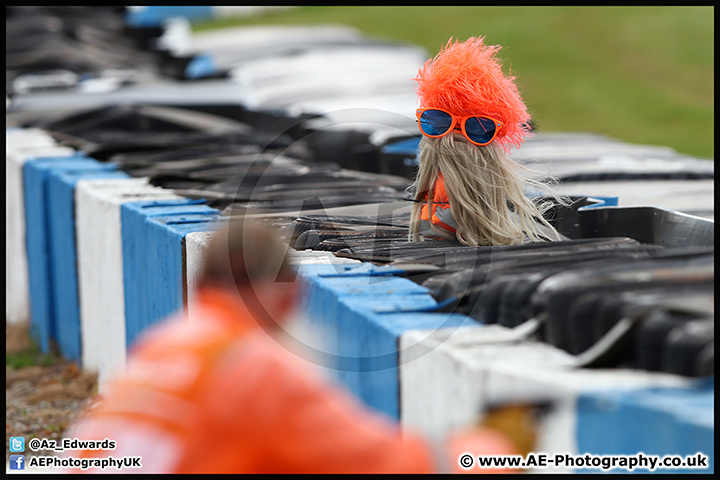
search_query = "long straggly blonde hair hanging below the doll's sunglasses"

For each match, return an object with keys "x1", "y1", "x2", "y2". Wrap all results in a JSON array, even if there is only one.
[{"x1": 409, "y1": 132, "x2": 567, "y2": 246}]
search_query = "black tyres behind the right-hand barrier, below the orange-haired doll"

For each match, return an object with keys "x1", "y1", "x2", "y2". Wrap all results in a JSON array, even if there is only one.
[{"x1": 285, "y1": 210, "x2": 714, "y2": 377}]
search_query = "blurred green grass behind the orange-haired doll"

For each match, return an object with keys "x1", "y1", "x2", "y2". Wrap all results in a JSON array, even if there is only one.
[{"x1": 193, "y1": 6, "x2": 714, "y2": 158}]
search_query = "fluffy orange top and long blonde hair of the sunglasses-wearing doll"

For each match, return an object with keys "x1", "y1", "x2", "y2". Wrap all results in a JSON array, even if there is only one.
[{"x1": 410, "y1": 38, "x2": 560, "y2": 246}]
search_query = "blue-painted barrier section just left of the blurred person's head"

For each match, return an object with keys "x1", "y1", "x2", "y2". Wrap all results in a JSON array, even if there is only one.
[{"x1": 120, "y1": 199, "x2": 220, "y2": 346}]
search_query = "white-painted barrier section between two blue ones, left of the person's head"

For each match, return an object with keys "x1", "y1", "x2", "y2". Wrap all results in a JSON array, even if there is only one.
[{"x1": 75, "y1": 178, "x2": 181, "y2": 391}]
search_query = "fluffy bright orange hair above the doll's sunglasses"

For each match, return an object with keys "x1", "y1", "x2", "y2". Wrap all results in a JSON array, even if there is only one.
[{"x1": 415, "y1": 37, "x2": 530, "y2": 151}]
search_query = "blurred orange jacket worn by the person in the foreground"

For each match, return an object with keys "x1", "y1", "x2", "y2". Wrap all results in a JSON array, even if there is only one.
[{"x1": 70, "y1": 290, "x2": 434, "y2": 473}]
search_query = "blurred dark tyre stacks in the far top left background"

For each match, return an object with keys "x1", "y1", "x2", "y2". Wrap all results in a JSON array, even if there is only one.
[{"x1": 6, "y1": 6, "x2": 218, "y2": 96}]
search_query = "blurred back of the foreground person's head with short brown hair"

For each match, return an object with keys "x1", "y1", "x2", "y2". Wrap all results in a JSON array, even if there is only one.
[{"x1": 197, "y1": 217, "x2": 298, "y2": 328}]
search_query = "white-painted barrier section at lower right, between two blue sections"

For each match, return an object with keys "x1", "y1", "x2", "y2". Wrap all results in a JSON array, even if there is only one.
[{"x1": 400, "y1": 325, "x2": 688, "y2": 472}]
